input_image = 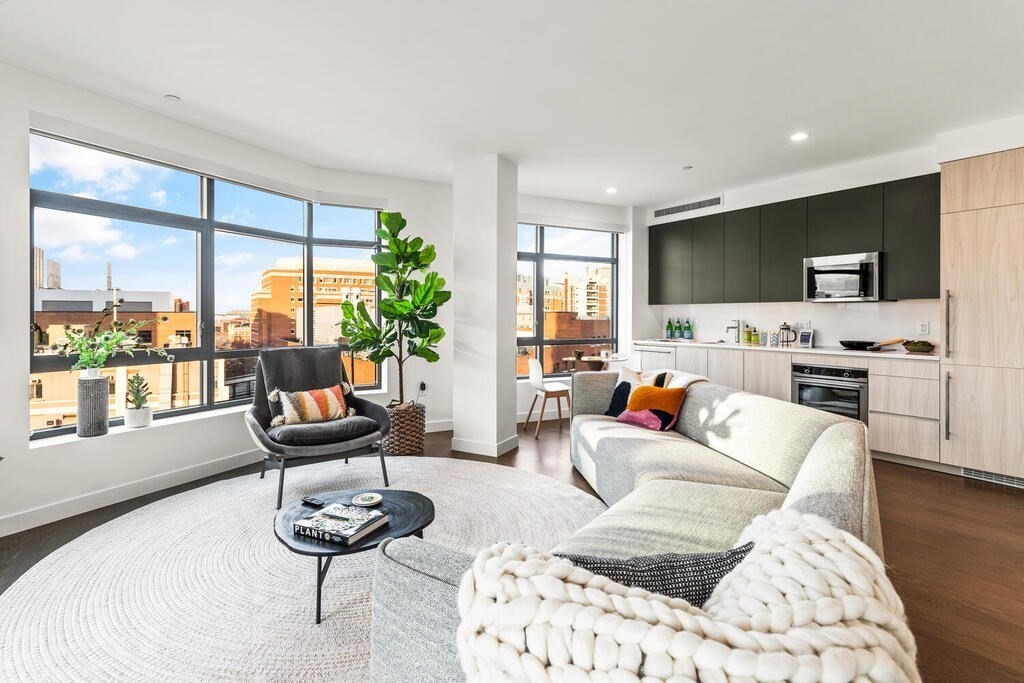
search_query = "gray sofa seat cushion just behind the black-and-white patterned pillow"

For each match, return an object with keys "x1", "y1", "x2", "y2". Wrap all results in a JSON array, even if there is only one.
[{"x1": 551, "y1": 479, "x2": 785, "y2": 558}]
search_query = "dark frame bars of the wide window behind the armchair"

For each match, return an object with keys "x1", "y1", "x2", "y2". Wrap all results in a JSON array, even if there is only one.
[{"x1": 29, "y1": 129, "x2": 383, "y2": 440}]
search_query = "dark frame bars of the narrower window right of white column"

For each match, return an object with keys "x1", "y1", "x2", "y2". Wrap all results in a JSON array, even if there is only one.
[{"x1": 516, "y1": 222, "x2": 620, "y2": 379}]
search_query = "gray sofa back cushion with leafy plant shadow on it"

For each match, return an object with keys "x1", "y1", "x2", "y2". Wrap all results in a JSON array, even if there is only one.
[{"x1": 676, "y1": 383, "x2": 853, "y2": 487}]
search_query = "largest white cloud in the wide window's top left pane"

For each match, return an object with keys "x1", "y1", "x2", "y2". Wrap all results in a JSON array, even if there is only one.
[{"x1": 29, "y1": 135, "x2": 150, "y2": 196}]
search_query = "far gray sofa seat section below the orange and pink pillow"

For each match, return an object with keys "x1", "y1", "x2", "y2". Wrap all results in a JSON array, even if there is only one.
[{"x1": 571, "y1": 415, "x2": 786, "y2": 505}]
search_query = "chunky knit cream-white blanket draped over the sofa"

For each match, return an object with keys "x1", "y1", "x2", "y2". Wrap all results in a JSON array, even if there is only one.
[{"x1": 459, "y1": 511, "x2": 921, "y2": 683}]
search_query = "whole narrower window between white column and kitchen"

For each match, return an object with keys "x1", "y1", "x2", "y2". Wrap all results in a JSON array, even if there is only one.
[{"x1": 516, "y1": 223, "x2": 618, "y2": 377}]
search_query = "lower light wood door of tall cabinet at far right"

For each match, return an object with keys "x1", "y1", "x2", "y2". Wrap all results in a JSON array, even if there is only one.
[{"x1": 940, "y1": 364, "x2": 1024, "y2": 477}]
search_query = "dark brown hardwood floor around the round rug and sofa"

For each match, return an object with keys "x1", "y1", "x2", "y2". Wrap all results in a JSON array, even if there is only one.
[{"x1": 0, "y1": 422, "x2": 1024, "y2": 683}]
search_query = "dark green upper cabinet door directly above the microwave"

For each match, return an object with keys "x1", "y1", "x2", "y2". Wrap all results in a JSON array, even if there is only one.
[{"x1": 807, "y1": 184, "x2": 883, "y2": 256}]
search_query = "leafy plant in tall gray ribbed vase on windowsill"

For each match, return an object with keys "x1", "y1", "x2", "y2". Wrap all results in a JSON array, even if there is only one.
[{"x1": 58, "y1": 299, "x2": 167, "y2": 436}]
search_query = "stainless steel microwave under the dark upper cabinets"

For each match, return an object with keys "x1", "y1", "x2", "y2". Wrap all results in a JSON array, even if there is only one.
[{"x1": 804, "y1": 252, "x2": 882, "y2": 303}]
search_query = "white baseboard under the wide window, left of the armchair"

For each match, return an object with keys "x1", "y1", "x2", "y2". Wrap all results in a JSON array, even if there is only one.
[{"x1": 0, "y1": 450, "x2": 263, "y2": 537}]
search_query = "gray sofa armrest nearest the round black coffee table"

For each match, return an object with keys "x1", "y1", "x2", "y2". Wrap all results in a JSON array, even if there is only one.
[{"x1": 370, "y1": 539, "x2": 473, "y2": 683}]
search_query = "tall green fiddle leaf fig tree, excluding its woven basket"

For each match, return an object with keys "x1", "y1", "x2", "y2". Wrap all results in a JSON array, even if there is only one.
[{"x1": 339, "y1": 212, "x2": 452, "y2": 403}]
